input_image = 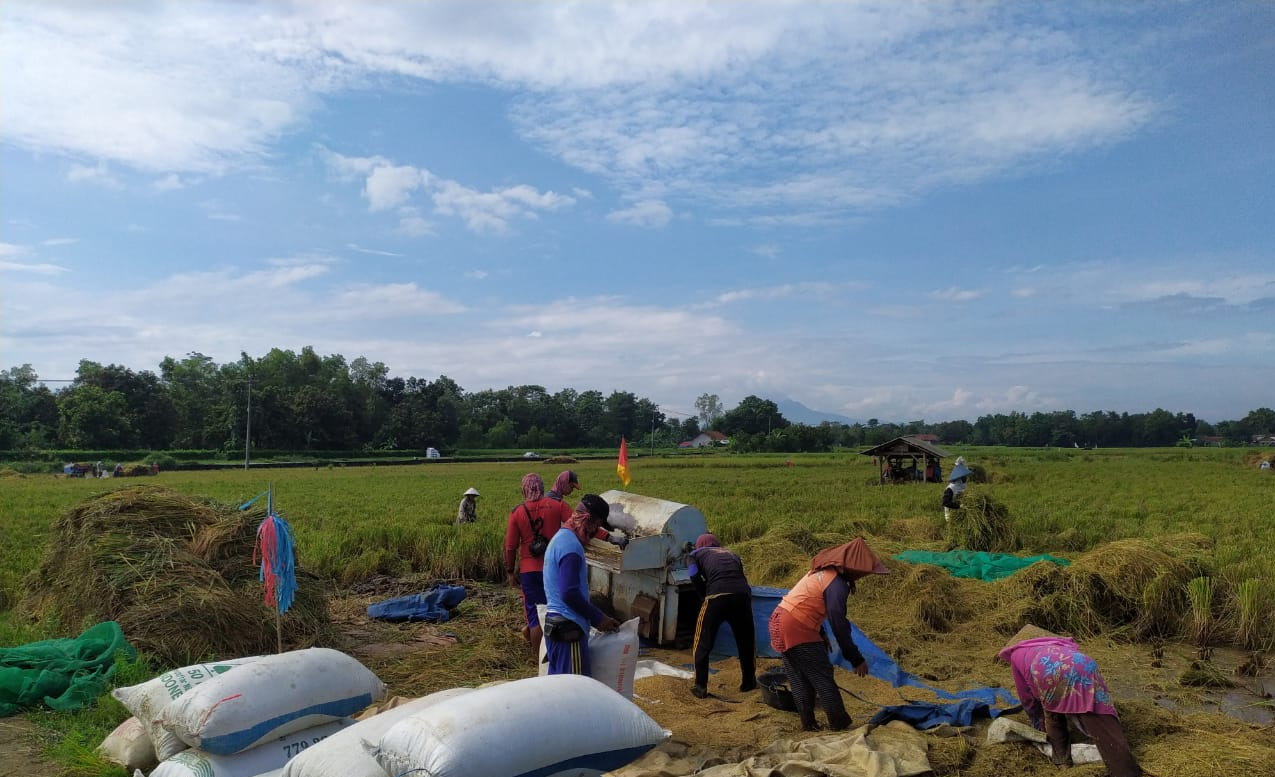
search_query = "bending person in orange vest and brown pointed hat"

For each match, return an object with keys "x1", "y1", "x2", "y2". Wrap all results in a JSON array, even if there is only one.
[{"x1": 770, "y1": 537, "x2": 887, "y2": 731}]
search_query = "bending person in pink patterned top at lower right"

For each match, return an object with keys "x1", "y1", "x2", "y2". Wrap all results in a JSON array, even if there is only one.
[{"x1": 996, "y1": 624, "x2": 1142, "y2": 777}]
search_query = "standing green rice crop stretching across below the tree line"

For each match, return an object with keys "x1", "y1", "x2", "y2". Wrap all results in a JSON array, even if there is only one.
[{"x1": 0, "y1": 448, "x2": 1275, "y2": 607}]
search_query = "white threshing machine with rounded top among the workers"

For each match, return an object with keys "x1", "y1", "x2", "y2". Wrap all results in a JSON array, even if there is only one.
[{"x1": 587, "y1": 491, "x2": 709, "y2": 646}]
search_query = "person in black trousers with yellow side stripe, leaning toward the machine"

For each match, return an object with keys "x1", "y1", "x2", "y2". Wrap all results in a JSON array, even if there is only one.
[{"x1": 689, "y1": 533, "x2": 757, "y2": 699}]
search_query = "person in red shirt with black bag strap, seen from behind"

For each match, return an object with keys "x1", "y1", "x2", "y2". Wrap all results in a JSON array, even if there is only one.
[{"x1": 505, "y1": 472, "x2": 562, "y2": 646}]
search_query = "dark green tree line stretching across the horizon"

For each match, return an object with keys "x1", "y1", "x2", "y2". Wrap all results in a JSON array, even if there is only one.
[{"x1": 0, "y1": 346, "x2": 1275, "y2": 452}]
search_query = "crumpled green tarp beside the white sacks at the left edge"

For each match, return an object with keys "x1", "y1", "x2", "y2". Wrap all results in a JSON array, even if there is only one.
[{"x1": 0, "y1": 620, "x2": 138, "y2": 717}]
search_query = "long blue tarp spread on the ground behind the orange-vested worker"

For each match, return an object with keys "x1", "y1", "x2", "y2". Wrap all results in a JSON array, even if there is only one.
[{"x1": 713, "y1": 586, "x2": 1019, "y2": 729}]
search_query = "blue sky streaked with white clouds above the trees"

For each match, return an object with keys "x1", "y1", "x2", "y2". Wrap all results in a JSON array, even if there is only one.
[{"x1": 0, "y1": 0, "x2": 1275, "y2": 421}]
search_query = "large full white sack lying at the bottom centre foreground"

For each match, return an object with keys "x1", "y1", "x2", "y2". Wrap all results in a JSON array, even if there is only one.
[{"x1": 372, "y1": 675, "x2": 668, "y2": 777}]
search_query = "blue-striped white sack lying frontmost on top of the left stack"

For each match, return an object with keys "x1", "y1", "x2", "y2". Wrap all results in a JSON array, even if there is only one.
[{"x1": 163, "y1": 648, "x2": 385, "y2": 755}]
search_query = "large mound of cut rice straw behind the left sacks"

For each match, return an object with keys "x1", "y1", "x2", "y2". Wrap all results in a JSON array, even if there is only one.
[{"x1": 20, "y1": 486, "x2": 328, "y2": 665}]
